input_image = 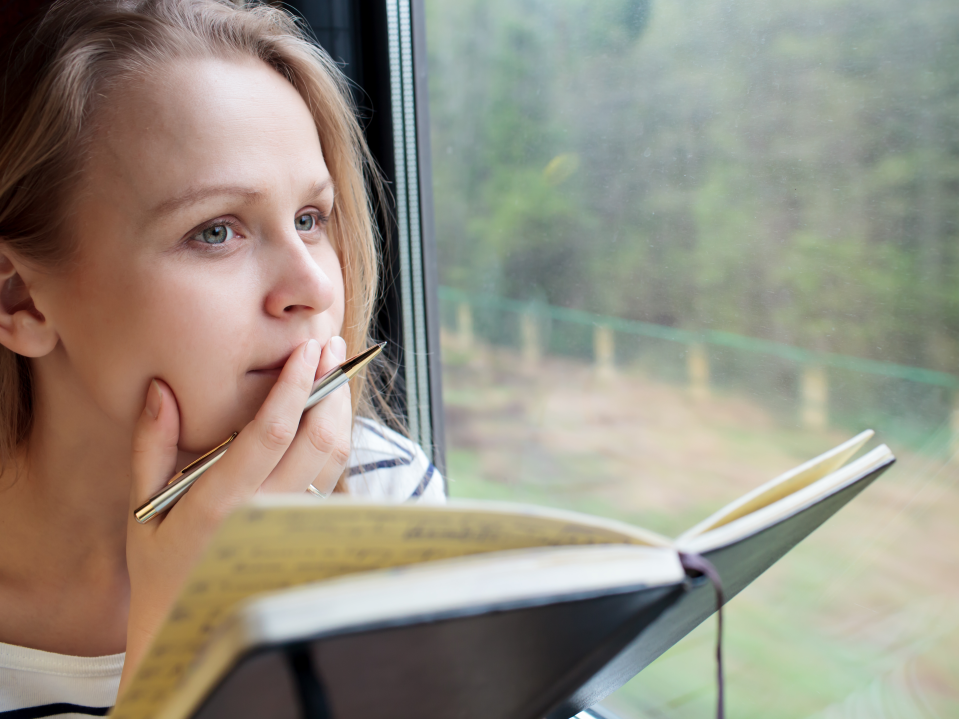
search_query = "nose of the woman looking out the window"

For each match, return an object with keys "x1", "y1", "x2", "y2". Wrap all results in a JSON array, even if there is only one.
[{"x1": 264, "y1": 231, "x2": 335, "y2": 318}]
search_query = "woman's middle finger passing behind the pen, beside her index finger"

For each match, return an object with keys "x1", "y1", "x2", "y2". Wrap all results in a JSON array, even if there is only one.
[{"x1": 261, "y1": 337, "x2": 353, "y2": 493}]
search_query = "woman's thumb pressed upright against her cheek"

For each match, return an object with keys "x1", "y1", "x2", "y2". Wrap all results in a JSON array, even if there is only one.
[{"x1": 130, "y1": 379, "x2": 180, "y2": 508}]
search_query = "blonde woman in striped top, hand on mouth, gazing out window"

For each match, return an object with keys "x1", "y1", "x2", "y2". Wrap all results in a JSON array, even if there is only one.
[{"x1": 0, "y1": 0, "x2": 442, "y2": 716}]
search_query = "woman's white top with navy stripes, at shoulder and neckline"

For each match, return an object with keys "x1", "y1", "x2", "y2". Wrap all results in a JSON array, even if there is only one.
[{"x1": 0, "y1": 418, "x2": 446, "y2": 719}]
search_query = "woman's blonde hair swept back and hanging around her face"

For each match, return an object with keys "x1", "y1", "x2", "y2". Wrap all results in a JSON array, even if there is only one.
[{"x1": 0, "y1": 0, "x2": 395, "y2": 484}]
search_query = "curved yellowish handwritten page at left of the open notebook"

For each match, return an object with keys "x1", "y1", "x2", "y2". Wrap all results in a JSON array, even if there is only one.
[{"x1": 111, "y1": 497, "x2": 663, "y2": 719}]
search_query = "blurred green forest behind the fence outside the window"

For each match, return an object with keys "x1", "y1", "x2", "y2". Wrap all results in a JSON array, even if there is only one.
[{"x1": 426, "y1": 0, "x2": 959, "y2": 372}]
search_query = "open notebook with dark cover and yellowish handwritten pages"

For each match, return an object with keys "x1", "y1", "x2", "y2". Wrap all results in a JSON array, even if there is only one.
[{"x1": 113, "y1": 432, "x2": 894, "y2": 719}]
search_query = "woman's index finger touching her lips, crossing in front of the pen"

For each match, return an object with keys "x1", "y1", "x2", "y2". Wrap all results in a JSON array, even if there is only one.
[{"x1": 186, "y1": 340, "x2": 320, "y2": 516}]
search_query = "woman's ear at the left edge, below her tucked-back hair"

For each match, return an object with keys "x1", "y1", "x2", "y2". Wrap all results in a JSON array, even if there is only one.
[{"x1": 0, "y1": 252, "x2": 60, "y2": 357}]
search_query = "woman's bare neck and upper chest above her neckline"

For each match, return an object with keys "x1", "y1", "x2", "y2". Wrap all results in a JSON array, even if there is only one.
[{"x1": 0, "y1": 357, "x2": 132, "y2": 656}]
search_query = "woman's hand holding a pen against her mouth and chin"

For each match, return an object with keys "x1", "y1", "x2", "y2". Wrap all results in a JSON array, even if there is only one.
[{"x1": 120, "y1": 337, "x2": 352, "y2": 690}]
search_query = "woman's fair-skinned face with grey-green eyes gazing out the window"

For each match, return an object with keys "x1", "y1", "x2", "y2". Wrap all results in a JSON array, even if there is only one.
[{"x1": 34, "y1": 59, "x2": 344, "y2": 452}]
